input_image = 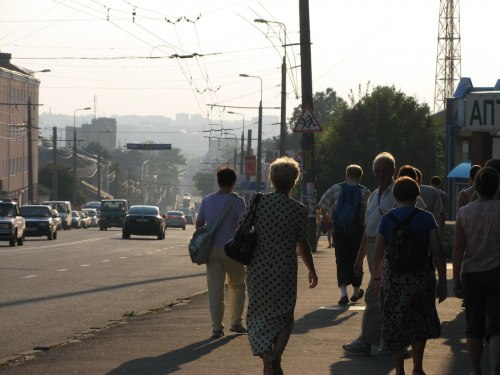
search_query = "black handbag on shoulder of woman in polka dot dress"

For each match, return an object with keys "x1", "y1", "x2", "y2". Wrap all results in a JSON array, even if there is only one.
[{"x1": 224, "y1": 193, "x2": 262, "y2": 265}]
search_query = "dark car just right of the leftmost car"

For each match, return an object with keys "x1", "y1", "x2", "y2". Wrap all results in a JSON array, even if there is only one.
[{"x1": 19, "y1": 205, "x2": 57, "y2": 241}]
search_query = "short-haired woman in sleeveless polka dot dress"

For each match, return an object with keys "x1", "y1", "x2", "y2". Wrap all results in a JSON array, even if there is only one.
[{"x1": 240, "y1": 157, "x2": 318, "y2": 375}]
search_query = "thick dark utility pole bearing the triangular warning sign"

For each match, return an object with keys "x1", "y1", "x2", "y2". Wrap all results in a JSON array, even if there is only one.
[{"x1": 299, "y1": 0, "x2": 317, "y2": 252}]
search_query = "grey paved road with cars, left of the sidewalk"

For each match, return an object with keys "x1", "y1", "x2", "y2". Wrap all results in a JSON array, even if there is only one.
[{"x1": 0, "y1": 226, "x2": 206, "y2": 358}]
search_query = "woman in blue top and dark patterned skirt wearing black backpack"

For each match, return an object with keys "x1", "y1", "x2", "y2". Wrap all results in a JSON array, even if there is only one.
[{"x1": 373, "y1": 176, "x2": 447, "y2": 375}]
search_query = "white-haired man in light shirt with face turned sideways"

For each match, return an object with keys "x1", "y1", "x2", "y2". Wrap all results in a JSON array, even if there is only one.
[{"x1": 342, "y1": 152, "x2": 396, "y2": 354}]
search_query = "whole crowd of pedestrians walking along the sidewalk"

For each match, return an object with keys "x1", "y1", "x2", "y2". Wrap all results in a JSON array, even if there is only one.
[{"x1": 193, "y1": 152, "x2": 500, "y2": 375}]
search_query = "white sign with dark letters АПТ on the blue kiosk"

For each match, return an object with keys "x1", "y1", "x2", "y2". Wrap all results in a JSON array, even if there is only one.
[{"x1": 462, "y1": 92, "x2": 500, "y2": 131}]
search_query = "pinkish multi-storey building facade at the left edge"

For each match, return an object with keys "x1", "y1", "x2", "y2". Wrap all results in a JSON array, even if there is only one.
[{"x1": 0, "y1": 53, "x2": 40, "y2": 204}]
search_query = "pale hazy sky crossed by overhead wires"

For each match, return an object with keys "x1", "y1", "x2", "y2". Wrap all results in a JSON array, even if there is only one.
[{"x1": 0, "y1": 0, "x2": 500, "y2": 129}]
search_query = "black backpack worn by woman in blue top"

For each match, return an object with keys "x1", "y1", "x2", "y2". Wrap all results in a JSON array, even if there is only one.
[{"x1": 386, "y1": 208, "x2": 428, "y2": 273}]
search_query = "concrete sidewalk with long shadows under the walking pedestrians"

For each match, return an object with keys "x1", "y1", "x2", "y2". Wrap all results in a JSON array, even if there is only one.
[{"x1": 0, "y1": 237, "x2": 489, "y2": 375}]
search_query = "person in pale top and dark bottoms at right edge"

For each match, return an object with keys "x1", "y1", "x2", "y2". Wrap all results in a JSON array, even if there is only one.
[{"x1": 453, "y1": 167, "x2": 500, "y2": 375}]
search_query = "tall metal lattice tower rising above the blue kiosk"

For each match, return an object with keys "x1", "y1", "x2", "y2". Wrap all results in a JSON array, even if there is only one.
[{"x1": 434, "y1": 0, "x2": 462, "y2": 113}]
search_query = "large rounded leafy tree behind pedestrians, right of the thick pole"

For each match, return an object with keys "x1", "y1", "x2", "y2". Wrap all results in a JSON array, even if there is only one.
[{"x1": 316, "y1": 86, "x2": 444, "y2": 197}]
